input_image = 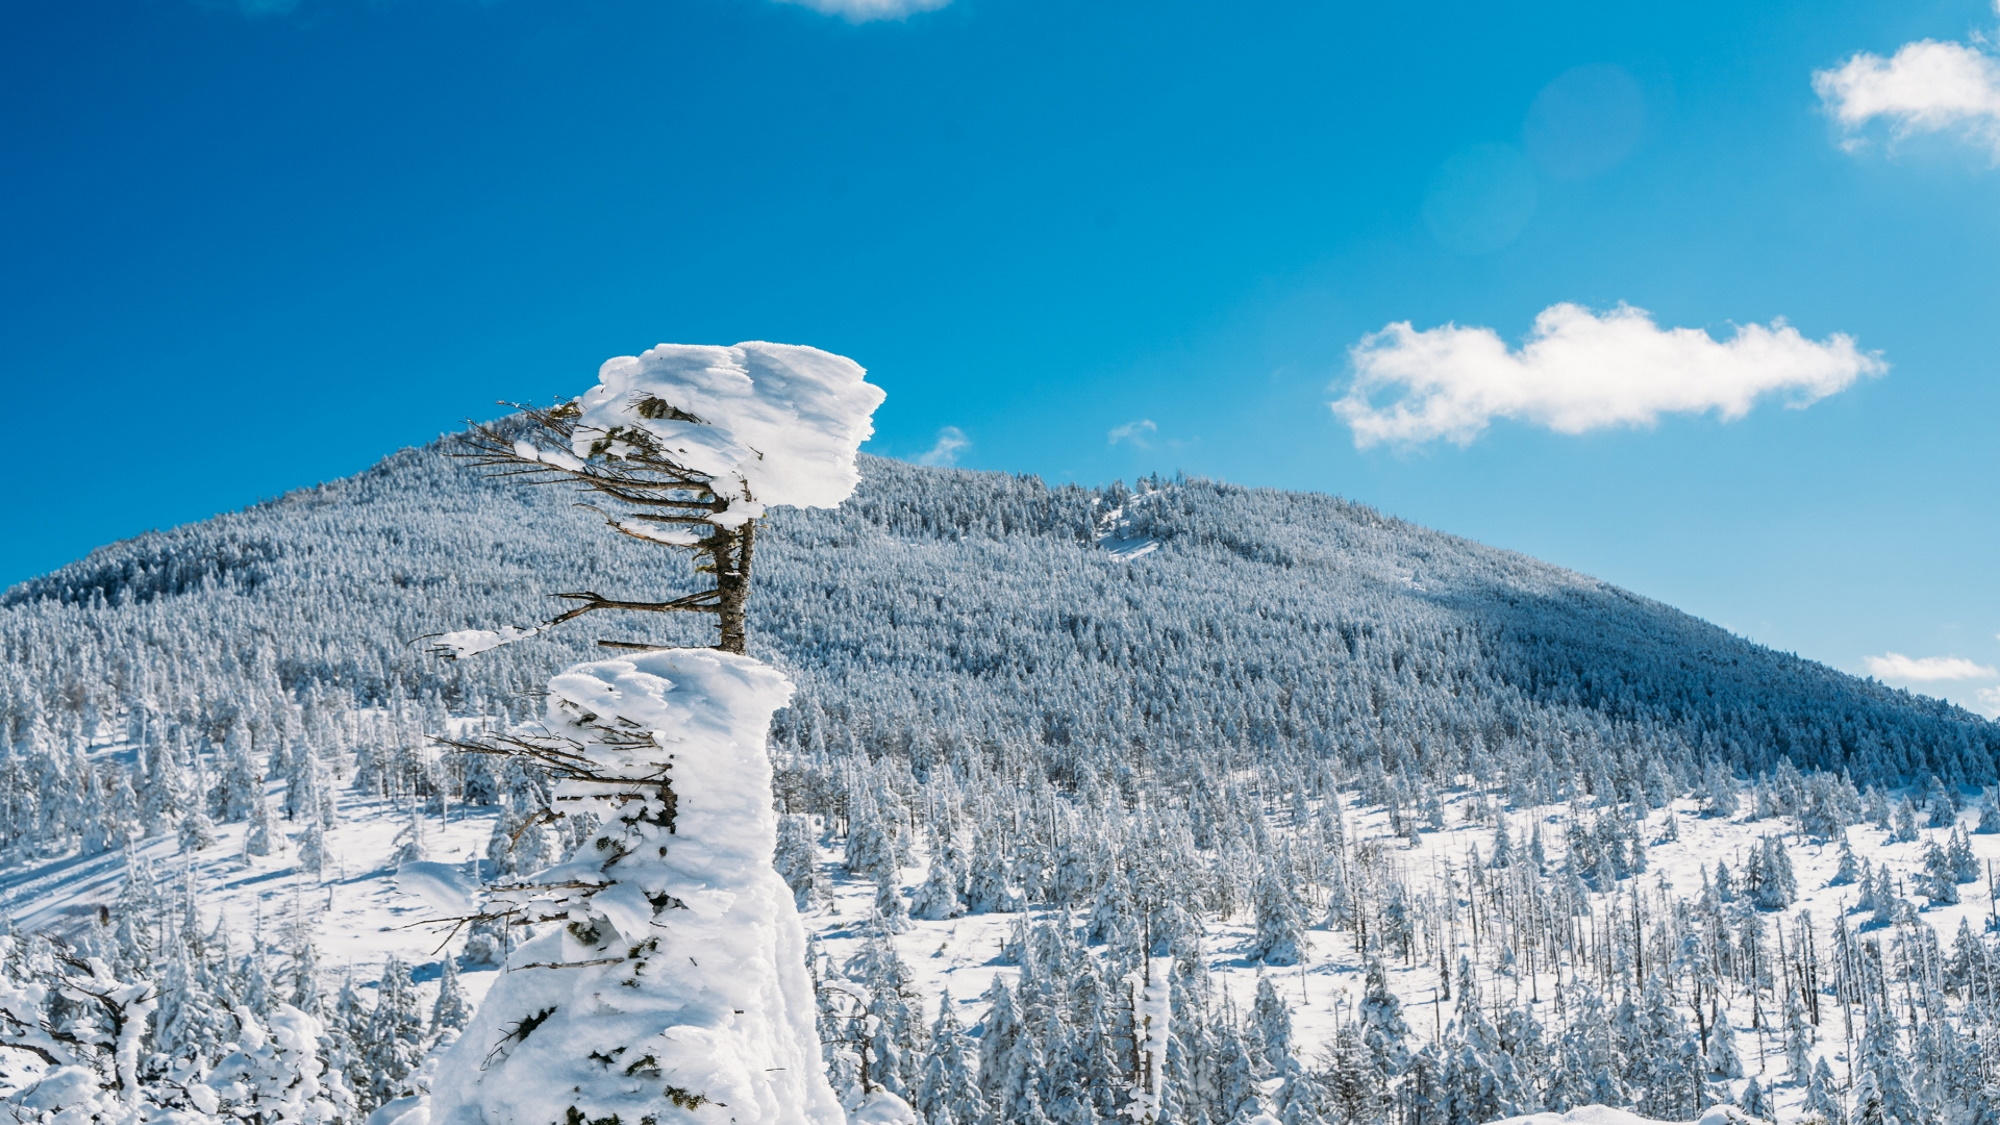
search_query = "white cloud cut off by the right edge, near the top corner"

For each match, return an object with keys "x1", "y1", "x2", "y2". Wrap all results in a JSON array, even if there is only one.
[{"x1": 1812, "y1": 40, "x2": 2000, "y2": 158}]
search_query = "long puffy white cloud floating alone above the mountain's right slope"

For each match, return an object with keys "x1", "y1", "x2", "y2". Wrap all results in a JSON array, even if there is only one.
[{"x1": 1332, "y1": 302, "x2": 1888, "y2": 448}]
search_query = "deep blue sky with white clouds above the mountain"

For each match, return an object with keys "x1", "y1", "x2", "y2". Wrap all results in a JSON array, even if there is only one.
[{"x1": 0, "y1": 0, "x2": 2000, "y2": 713}]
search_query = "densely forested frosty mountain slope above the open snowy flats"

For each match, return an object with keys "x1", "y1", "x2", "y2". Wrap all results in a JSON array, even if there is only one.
[{"x1": 0, "y1": 438, "x2": 2000, "y2": 841}]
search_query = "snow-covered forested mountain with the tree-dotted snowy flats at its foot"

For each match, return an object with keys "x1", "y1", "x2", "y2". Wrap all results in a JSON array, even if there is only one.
[{"x1": 0, "y1": 446, "x2": 2000, "y2": 1125}]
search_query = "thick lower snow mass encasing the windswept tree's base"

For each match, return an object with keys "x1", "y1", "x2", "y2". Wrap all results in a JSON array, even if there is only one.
[{"x1": 430, "y1": 649, "x2": 844, "y2": 1125}]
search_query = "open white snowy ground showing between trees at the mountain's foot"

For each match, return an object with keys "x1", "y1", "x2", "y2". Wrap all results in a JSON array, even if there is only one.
[{"x1": 0, "y1": 751, "x2": 2000, "y2": 1125}]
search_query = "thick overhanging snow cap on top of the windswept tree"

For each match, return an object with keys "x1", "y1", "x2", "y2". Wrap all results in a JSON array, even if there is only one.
[{"x1": 574, "y1": 342, "x2": 882, "y2": 526}]
